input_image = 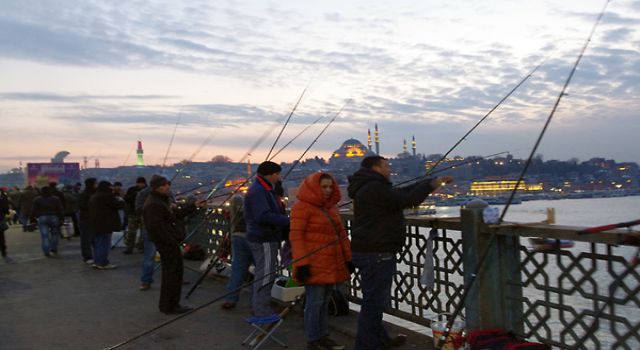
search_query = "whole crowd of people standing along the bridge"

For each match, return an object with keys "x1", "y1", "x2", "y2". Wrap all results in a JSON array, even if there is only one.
[{"x1": 0, "y1": 156, "x2": 452, "y2": 350}]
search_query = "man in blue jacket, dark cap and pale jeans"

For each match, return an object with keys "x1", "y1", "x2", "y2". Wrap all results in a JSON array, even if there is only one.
[{"x1": 244, "y1": 161, "x2": 289, "y2": 322}]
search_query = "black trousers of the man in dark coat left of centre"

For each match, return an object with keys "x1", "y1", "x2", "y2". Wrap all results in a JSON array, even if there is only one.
[{"x1": 157, "y1": 245, "x2": 184, "y2": 312}]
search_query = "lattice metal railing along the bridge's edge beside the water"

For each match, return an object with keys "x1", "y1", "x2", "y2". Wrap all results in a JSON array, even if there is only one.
[{"x1": 194, "y1": 206, "x2": 640, "y2": 349}]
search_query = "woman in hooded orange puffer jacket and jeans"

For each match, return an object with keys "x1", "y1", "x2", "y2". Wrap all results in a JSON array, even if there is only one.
[{"x1": 289, "y1": 172, "x2": 354, "y2": 350}]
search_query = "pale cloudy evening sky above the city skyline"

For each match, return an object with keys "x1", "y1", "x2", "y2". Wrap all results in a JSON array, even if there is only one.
[{"x1": 0, "y1": 0, "x2": 640, "y2": 171}]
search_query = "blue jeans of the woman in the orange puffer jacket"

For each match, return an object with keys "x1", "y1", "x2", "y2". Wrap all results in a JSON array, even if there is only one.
[{"x1": 304, "y1": 284, "x2": 335, "y2": 342}]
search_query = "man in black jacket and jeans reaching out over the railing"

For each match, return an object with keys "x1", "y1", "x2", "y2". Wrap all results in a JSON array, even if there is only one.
[{"x1": 348, "y1": 156, "x2": 452, "y2": 350}]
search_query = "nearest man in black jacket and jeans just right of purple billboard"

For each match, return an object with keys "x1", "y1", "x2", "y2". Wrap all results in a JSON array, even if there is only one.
[{"x1": 89, "y1": 181, "x2": 124, "y2": 270}]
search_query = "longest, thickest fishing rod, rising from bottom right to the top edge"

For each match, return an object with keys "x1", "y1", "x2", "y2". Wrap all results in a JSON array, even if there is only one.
[{"x1": 436, "y1": 0, "x2": 609, "y2": 350}]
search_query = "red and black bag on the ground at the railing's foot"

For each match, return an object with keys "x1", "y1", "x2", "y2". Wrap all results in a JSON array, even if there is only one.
[{"x1": 467, "y1": 328, "x2": 551, "y2": 350}]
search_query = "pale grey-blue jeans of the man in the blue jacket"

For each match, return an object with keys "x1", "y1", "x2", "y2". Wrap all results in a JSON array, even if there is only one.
[{"x1": 249, "y1": 242, "x2": 279, "y2": 317}]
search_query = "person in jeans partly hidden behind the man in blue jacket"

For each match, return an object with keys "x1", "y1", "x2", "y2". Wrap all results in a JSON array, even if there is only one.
[{"x1": 221, "y1": 194, "x2": 254, "y2": 310}]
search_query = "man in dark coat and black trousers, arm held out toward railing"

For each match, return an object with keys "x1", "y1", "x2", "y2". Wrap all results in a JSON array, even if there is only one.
[{"x1": 142, "y1": 175, "x2": 206, "y2": 315}]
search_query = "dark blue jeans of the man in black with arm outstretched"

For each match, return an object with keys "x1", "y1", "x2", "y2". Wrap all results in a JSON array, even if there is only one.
[{"x1": 352, "y1": 252, "x2": 396, "y2": 350}]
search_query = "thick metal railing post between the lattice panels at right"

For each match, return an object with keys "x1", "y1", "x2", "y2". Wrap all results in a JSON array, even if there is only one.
[{"x1": 460, "y1": 201, "x2": 524, "y2": 333}]
